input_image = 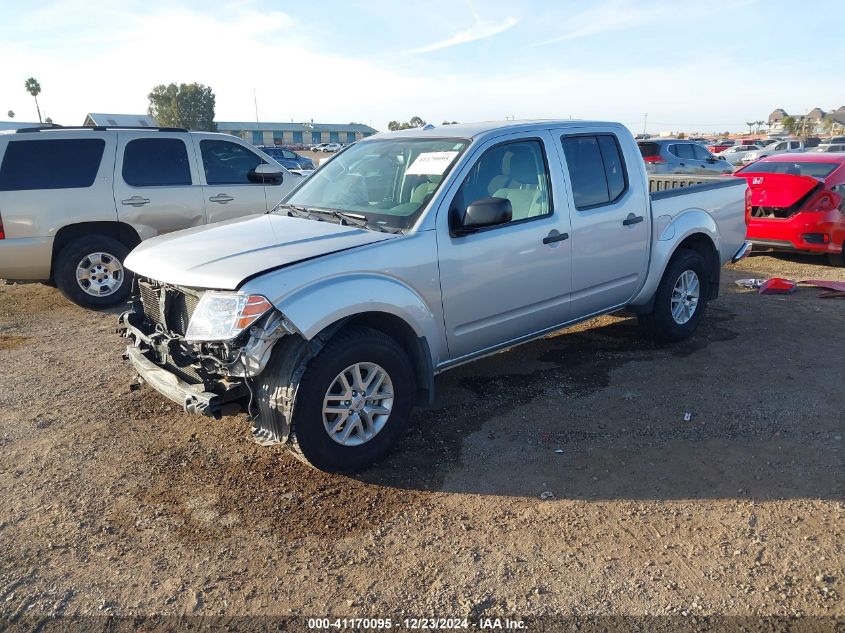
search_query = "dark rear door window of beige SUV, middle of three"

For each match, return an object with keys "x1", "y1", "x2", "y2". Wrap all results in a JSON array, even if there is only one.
[{"x1": 122, "y1": 138, "x2": 191, "y2": 187}]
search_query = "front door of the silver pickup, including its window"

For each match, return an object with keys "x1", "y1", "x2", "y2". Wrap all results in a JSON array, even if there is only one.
[{"x1": 437, "y1": 132, "x2": 571, "y2": 359}]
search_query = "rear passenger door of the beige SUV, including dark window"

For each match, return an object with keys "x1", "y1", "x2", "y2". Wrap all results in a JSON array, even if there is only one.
[{"x1": 114, "y1": 131, "x2": 205, "y2": 239}]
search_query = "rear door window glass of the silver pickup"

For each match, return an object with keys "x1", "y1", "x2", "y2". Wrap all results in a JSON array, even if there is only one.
[{"x1": 561, "y1": 134, "x2": 628, "y2": 210}]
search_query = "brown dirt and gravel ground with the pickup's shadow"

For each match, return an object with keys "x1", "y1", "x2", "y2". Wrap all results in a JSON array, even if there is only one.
[{"x1": 0, "y1": 251, "x2": 845, "y2": 630}]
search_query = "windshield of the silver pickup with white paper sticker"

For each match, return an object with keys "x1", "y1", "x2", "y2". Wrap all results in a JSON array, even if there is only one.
[{"x1": 282, "y1": 138, "x2": 469, "y2": 229}]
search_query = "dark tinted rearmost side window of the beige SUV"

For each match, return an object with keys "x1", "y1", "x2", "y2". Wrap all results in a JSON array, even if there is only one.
[{"x1": 0, "y1": 138, "x2": 106, "y2": 191}]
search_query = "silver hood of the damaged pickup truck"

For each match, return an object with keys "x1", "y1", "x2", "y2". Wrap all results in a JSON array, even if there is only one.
[{"x1": 125, "y1": 214, "x2": 399, "y2": 290}]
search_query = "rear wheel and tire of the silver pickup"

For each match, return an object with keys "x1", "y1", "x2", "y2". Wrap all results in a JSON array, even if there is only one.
[{"x1": 637, "y1": 248, "x2": 710, "y2": 343}]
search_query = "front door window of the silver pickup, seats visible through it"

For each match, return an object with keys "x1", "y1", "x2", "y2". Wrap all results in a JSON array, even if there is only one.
[{"x1": 453, "y1": 140, "x2": 551, "y2": 222}]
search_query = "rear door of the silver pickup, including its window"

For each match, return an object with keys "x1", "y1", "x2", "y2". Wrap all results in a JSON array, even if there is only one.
[{"x1": 558, "y1": 128, "x2": 648, "y2": 318}]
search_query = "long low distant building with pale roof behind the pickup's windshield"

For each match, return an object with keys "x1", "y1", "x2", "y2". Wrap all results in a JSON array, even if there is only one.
[{"x1": 217, "y1": 121, "x2": 378, "y2": 145}]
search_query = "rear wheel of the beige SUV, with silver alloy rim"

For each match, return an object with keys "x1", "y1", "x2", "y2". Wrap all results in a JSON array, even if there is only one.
[{"x1": 53, "y1": 235, "x2": 132, "y2": 308}]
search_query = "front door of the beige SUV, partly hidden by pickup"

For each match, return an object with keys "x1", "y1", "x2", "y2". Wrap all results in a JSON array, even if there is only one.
[{"x1": 195, "y1": 138, "x2": 268, "y2": 223}]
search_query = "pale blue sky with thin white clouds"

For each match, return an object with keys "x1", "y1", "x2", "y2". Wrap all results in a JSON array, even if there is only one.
[{"x1": 0, "y1": 0, "x2": 845, "y2": 133}]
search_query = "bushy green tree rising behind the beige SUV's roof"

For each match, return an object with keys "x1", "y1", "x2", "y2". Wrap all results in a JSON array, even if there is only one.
[{"x1": 147, "y1": 82, "x2": 217, "y2": 132}]
